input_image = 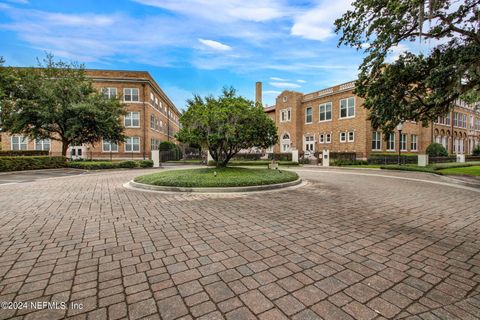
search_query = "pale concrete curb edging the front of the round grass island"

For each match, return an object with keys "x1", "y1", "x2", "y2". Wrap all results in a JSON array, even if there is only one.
[{"x1": 126, "y1": 178, "x2": 302, "y2": 193}]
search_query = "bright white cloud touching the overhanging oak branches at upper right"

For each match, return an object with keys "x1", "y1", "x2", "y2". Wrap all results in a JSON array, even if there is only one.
[{"x1": 290, "y1": 0, "x2": 351, "y2": 41}]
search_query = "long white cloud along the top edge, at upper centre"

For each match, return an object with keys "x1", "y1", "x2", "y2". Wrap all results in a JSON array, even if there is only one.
[{"x1": 133, "y1": 0, "x2": 287, "y2": 22}]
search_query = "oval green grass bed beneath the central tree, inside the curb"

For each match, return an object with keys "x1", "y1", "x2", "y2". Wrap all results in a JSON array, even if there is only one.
[{"x1": 135, "y1": 167, "x2": 298, "y2": 188}]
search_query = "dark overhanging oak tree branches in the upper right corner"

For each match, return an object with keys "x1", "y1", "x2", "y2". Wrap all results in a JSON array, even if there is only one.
[{"x1": 335, "y1": 0, "x2": 480, "y2": 132}]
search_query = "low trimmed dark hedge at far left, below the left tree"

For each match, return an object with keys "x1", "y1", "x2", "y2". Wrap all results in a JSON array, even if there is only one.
[{"x1": 0, "y1": 156, "x2": 67, "y2": 171}]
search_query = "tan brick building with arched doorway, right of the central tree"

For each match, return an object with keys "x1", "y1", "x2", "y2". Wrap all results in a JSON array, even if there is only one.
[{"x1": 262, "y1": 81, "x2": 480, "y2": 159}]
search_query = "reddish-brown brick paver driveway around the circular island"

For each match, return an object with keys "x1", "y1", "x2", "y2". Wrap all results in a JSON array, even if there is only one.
[{"x1": 0, "y1": 169, "x2": 480, "y2": 319}]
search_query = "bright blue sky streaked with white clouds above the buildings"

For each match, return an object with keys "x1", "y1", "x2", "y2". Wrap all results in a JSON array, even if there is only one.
[{"x1": 0, "y1": 0, "x2": 386, "y2": 108}]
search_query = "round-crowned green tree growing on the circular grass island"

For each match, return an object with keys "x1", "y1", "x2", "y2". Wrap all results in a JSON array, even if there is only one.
[{"x1": 177, "y1": 88, "x2": 278, "y2": 167}]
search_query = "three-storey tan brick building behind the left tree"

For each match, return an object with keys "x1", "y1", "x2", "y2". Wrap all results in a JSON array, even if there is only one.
[{"x1": 1, "y1": 70, "x2": 180, "y2": 159}]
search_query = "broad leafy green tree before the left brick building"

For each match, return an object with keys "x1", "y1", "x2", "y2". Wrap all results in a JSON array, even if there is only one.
[{"x1": 0, "y1": 55, "x2": 125, "y2": 156}]
